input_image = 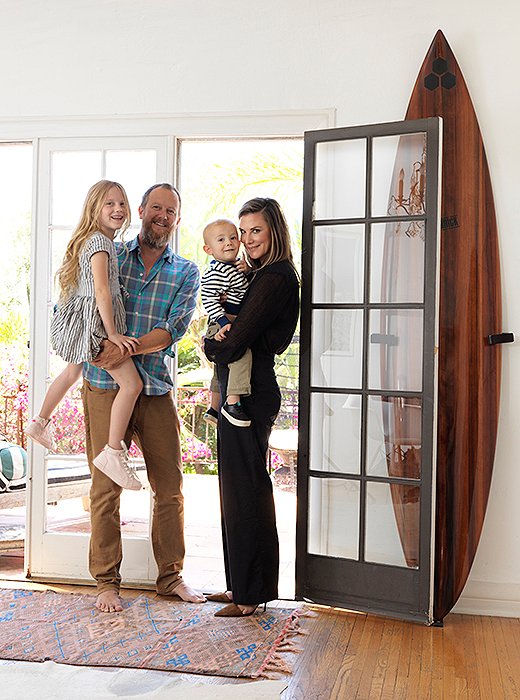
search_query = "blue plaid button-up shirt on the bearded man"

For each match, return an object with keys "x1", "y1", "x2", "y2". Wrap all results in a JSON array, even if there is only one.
[{"x1": 83, "y1": 237, "x2": 200, "y2": 396}]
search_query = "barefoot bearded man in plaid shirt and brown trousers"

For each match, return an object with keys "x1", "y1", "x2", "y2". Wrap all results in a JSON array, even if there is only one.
[{"x1": 82, "y1": 183, "x2": 206, "y2": 612}]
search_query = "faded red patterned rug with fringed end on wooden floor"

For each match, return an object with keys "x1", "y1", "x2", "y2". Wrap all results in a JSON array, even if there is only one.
[{"x1": 0, "y1": 589, "x2": 302, "y2": 678}]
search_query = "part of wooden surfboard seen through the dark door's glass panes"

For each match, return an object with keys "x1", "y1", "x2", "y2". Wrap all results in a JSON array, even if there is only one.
[{"x1": 380, "y1": 133, "x2": 427, "y2": 568}]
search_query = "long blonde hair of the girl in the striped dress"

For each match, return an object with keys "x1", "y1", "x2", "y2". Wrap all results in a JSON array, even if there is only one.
[{"x1": 56, "y1": 180, "x2": 130, "y2": 299}]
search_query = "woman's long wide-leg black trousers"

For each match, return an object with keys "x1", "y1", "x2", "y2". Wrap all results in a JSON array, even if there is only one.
[{"x1": 217, "y1": 355, "x2": 281, "y2": 605}]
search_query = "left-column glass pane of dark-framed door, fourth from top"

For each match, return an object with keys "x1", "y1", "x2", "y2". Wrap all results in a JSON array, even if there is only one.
[{"x1": 309, "y1": 393, "x2": 361, "y2": 474}]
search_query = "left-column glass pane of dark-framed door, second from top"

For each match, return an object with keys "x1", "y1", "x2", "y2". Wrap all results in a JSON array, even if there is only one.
[{"x1": 312, "y1": 225, "x2": 365, "y2": 304}]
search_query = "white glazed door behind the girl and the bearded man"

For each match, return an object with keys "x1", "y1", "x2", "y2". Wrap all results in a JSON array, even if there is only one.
[{"x1": 26, "y1": 137, "x2": 173, "y2": 586}]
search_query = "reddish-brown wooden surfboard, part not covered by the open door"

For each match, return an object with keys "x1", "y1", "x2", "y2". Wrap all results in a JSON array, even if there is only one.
[{"x1": 406, "y1": 31, "x2": 502, "y2": 620}]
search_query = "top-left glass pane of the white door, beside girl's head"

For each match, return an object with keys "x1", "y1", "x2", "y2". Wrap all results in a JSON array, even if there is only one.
[{"x1": 50, "y1": 151, "x2": 103, "y2": 227}]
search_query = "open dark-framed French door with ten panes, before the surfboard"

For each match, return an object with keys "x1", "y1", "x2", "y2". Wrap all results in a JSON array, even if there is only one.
[{"x1": 296, "y1": 119, "x2": 441, "y2": 622}]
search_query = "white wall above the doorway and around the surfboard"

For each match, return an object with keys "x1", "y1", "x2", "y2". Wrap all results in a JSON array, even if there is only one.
[{"x1": 0, "y1": 0, "x2": 520, "y2": 615}]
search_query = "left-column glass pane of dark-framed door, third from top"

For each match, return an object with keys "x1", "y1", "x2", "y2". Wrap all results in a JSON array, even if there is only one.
[{"x1": 311, "y1": 309, "x2": 363, "y2": 389}]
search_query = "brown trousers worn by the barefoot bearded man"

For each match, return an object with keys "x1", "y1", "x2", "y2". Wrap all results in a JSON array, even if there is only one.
[{"x1": 82, "y1": 381, "x2": 184, "y2": 595}]
